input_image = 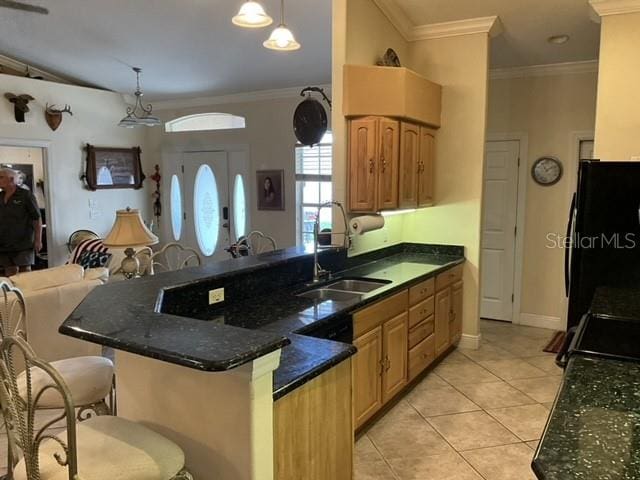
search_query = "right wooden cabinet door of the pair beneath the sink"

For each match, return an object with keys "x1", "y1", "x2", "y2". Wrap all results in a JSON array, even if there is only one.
[{"x1": 382, "y1": 312, "x2": 409, "y2": 403}]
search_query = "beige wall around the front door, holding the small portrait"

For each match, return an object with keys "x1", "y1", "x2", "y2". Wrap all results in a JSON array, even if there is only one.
[{"x1": 148, "y1": 95, "x2": 310, "y2": 248}]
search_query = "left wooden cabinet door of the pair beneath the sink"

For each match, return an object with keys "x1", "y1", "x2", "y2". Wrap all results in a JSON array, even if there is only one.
[{"x1": 352, "y1": 327, "x2": 383, "y2": 428}]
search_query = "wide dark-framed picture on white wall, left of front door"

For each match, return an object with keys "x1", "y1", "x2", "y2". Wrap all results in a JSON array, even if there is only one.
[{"x1": 84, "y1": 144, "x2": 144, "y2": 190}]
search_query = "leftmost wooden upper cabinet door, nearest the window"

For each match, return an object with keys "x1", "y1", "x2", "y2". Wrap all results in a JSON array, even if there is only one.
[{"x1": 349, "y1": 117, "x2": 378, "y2": 212}]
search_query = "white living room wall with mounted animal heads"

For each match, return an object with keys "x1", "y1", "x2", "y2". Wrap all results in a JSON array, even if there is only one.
[{"x1": 0, "y1": 74, "x2": 154, "y2": 265}]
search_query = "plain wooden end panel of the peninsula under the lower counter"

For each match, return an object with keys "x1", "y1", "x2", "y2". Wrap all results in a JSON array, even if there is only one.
[{"x1": 273, "y1": 360, "x2": 353, "y2": 480}]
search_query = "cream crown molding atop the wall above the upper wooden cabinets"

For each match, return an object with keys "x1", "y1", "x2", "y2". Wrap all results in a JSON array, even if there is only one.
[{"x1": 373, "y1": 0, "x2": 502, "y2": 42}]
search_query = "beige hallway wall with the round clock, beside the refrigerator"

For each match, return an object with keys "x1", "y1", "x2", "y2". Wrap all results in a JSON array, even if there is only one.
[{"x1": 488, "y1": 73, "x2": 597, "y2": 321}]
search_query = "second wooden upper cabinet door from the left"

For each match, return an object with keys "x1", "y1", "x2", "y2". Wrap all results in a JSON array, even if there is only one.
[{"x1": 378, "y1": 118, "x2": 400, "y2": 210}]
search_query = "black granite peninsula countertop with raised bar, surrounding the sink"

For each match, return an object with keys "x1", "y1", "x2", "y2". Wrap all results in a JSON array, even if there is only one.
[{"x1": 60, "y1": 244, "x2": 464, "y2": 399}]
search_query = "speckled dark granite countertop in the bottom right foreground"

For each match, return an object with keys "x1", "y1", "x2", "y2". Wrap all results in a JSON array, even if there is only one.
[{"x1": 533, "y1": 354, "x2": 640, "y2": 480}]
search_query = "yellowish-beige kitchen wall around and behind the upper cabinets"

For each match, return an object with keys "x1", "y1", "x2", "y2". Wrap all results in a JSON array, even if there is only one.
[{"x1": 333, "y1": 0, "x2": 489, "y2": 342}]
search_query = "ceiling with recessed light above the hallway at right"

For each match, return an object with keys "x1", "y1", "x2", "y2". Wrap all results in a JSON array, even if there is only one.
[{"x1": 394, "y1": 0, "x2": 600, "y2": 67}]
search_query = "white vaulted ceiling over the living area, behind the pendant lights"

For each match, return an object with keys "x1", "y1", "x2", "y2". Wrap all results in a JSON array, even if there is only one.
[{"x1": 0, "y1": 0, "x2": 331, "y2": 99}]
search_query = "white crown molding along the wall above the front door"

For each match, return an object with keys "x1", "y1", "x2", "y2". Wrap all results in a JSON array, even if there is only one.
[{"x1": 152, "y1": 84, "x2": 331, "y2": 111}]
